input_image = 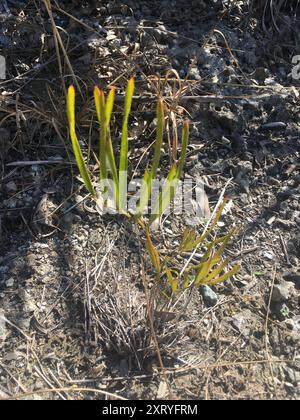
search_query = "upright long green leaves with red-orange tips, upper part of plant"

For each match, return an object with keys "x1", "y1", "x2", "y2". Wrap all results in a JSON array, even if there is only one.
[{"x1": 67, "y1": 79, "x2": 189, "y2": 224}]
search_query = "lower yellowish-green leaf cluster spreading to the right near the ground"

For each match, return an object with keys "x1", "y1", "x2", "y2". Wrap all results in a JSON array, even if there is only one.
[{"x1": 146, "y1": 199, "x2": 240, "y2": 294}]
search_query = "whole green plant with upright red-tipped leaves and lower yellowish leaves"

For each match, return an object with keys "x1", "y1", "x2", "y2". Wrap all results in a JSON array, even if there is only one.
[{"x1": 67, "y1": 79, "x2": 239, "y2": 294}]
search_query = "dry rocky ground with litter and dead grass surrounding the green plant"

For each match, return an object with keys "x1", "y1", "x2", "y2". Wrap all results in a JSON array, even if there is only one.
[{"x1": 0, "y1": 0, "x2": 300, "y2": 399}]
